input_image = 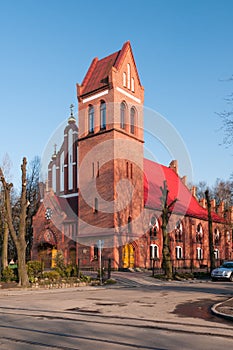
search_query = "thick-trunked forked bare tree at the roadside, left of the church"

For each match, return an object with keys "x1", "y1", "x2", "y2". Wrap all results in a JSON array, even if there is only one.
[{"x1": 0, "y1": 157, "x2": 29, "y2": 287}]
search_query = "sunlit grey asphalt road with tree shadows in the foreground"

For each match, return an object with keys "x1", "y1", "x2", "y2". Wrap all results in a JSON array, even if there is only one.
[{"x1": 0, "y1": 273, "x2": 233, "y2": 350}]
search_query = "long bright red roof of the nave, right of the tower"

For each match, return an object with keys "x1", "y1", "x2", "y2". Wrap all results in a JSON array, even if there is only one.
[{"x1": 144, "y1": 159, "x2": 224, "y2": 222}]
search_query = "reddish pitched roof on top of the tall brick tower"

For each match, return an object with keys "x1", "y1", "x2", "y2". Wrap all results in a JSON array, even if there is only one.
[{"x1": 81, "y1": 41, "x2": 140, "y2": 95}]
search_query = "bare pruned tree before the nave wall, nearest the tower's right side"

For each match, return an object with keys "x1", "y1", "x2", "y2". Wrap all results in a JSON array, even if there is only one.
[{"x1": 160, "y1": 180, "x2": 177, "y2": 279}]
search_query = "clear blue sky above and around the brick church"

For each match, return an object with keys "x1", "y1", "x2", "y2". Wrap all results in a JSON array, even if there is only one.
[{"x1": 0, "y1": 0, "x2": 233, "y2": 189}]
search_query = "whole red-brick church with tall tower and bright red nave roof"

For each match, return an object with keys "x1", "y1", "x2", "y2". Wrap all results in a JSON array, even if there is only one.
[{"x1": 32, "y1": 42, "x2": 233, "y2": 269}]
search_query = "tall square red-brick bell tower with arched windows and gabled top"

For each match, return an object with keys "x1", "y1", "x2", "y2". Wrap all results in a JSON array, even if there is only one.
[{"x1": 77, "y1": 41, "x2": 144, "y2": 252}]
